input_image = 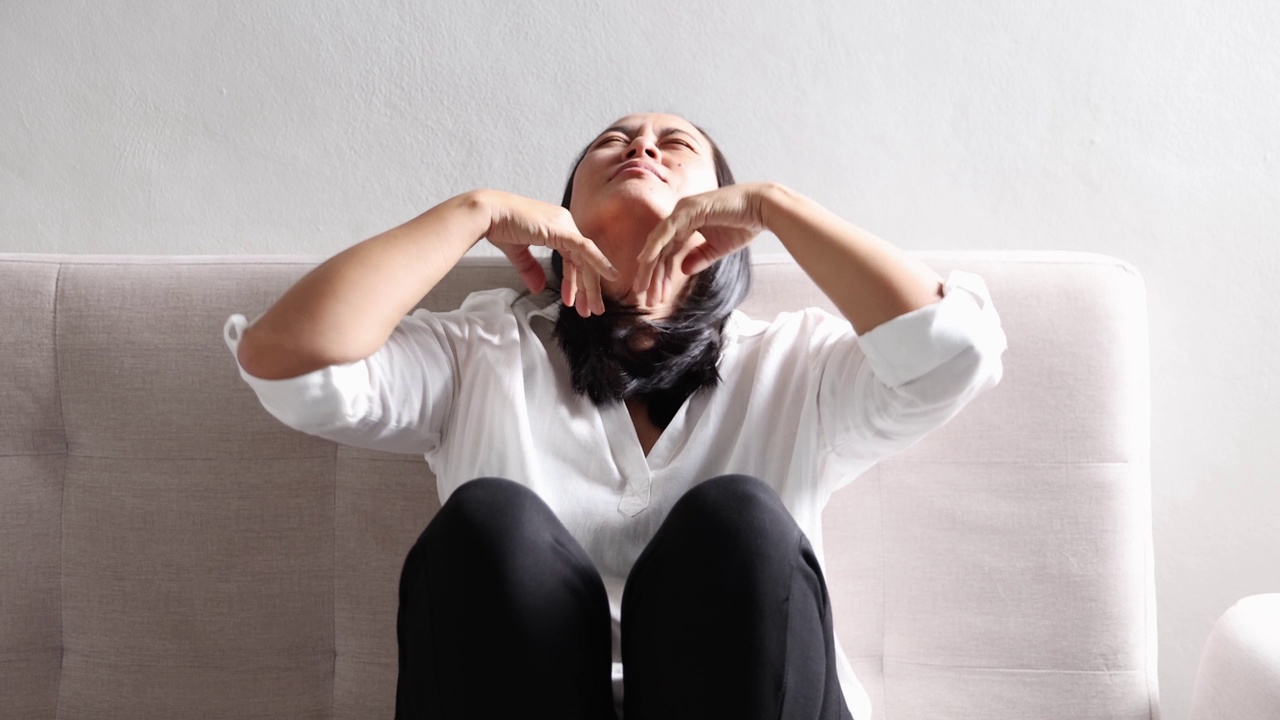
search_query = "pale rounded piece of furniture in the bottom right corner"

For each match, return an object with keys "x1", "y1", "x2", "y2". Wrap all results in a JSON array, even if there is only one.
[{"x1": 1190, "y1": 593, "x2": 1280, "y2": 720}]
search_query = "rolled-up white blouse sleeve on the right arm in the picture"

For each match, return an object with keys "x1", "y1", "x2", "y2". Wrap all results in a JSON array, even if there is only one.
[{"x1": 814, "y1": 270, "x2": 1007, "y2": 460}]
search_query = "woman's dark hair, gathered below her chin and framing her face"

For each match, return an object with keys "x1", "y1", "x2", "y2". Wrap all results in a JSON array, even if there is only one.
[{"x1": 548, "y1": 120, "x2": 751, "y2": 428}]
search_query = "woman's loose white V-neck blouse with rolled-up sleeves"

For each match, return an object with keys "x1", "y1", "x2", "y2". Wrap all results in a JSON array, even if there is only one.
[{"x1": 223, "y1": 265, "x2": 1007, "y2": 720}]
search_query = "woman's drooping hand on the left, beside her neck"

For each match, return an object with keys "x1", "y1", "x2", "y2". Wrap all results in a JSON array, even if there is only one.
[{"x1": 477, "y1": 190, "x2": 620, "y2": 318}]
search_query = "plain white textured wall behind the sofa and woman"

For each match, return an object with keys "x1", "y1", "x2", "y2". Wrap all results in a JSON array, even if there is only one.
[{"x1": 0, "y1": 0, "x2": 1280, "y2": 720}]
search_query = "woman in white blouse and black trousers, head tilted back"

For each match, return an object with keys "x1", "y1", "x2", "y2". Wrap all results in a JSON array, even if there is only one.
[{"x1": 225, "y1": 113, "x2": 1005, "y2": 720}]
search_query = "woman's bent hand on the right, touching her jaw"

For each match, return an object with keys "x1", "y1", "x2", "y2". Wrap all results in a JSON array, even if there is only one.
[{"x1": 631, "y1": 182, "x2": 774, "y2": 304}]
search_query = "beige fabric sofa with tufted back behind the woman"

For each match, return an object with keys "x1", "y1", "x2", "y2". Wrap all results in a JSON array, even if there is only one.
[{"x1": 0, "y1": 251, "x2": 1280, "y2": 720}]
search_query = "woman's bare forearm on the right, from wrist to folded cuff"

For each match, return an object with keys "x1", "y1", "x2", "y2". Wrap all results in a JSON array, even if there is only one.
[{"x1": 762, "y1": 184, "x2": 943, "y2": 334}]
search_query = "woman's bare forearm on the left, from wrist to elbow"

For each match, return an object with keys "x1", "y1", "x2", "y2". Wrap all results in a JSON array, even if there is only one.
[{"x1": 237, "y1": 192, "x2": 490, "y2": 379}]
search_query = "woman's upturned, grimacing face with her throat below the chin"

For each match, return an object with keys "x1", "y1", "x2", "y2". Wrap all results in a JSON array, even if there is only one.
[{"x1": 570, "y1": 113, "x2": 717, "y2": 287}]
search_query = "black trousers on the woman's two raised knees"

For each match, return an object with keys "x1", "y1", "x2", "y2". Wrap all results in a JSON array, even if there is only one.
[{"x1": 396, "y1": 475, "x2": 850, "y2": 720}]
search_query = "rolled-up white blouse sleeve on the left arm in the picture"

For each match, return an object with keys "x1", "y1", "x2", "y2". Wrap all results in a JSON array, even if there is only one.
[{"x1": 223, "y1": 310, "x2": 457, "y2": 455}]
